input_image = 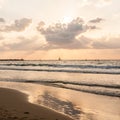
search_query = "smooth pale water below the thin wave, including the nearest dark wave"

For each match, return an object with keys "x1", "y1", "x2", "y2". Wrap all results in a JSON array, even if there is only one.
[{"x1": 0, "y1": 70, "x2": 120, "y2": 97}]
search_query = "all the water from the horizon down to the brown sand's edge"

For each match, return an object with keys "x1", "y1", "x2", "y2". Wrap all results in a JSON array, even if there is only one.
[{"x1": 0, "y1": 60, "x2": 120, "y2": 120}]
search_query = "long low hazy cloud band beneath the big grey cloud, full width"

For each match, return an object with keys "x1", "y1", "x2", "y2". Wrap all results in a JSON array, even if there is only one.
[{"x1": 0, "y1": 35, "x2": 120, "y2": 53}]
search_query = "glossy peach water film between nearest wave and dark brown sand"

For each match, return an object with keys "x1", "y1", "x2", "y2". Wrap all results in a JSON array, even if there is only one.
[{"x1": 0, "y1": 82, "x2": 120, "y2": 120}]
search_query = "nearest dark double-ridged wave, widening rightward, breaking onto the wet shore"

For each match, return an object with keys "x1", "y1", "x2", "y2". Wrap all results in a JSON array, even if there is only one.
[{"x1": 0, "y1": 79, "x2": 120, "y2": 97}]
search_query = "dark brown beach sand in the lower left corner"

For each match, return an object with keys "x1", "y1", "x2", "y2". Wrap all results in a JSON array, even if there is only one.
[{"x1": 0, "y1": 88, "x2": 72, "y2": 120}]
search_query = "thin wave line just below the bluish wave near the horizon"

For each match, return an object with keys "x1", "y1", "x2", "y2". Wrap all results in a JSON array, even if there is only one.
[{"x1": 0, "y1": 67, "x2": 120, "y2": 75}]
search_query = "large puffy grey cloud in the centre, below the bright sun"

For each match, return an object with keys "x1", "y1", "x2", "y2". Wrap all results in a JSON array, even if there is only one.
[{"x1": 37, "y1": 17, "x2": 97, "y2": 48}]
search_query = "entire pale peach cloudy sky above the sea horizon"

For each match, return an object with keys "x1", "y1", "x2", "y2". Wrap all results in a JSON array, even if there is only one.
[{"x1": 0, "y1": 0, "x2": 120, "y2": 60}]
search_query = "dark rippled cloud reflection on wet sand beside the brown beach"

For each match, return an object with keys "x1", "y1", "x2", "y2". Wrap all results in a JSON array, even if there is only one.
[{"x1": 37, "y1": 91, "x2": 81, "y2": 120}]
